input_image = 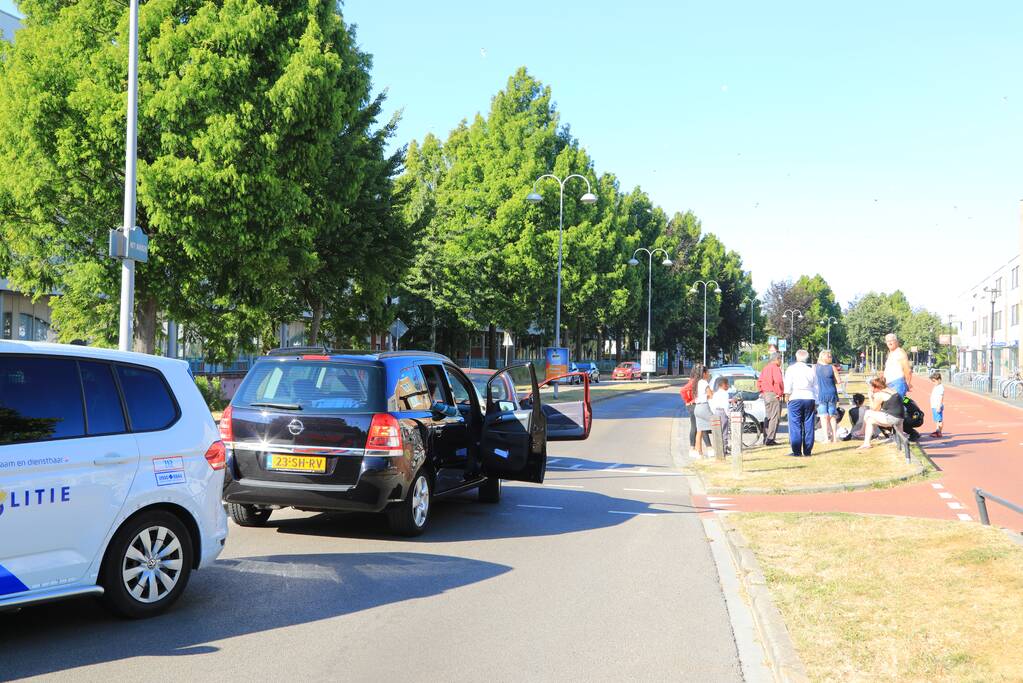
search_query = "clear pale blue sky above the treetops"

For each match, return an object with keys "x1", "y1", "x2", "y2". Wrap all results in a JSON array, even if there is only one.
[{"x1": 0, "y1": 0, "x2": 1023, "y2": 313}]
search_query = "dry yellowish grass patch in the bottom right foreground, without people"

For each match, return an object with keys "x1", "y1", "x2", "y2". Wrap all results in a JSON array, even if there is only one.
[{"x1": 728, "y1": 513, "x2": 1023, "y2": 681}]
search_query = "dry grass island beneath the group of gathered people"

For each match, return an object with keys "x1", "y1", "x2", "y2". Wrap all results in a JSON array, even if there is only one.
[{"x1": 694, "y1": 435, "x2": 919, "y2": 493}]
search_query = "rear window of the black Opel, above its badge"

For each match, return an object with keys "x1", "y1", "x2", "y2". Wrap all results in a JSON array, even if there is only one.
[{"x1": 231, "y1": 361, "x2": 387, "y2": 413}]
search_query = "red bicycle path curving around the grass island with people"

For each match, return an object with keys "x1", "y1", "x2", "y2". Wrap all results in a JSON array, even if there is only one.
[{"x1": 694, "y1": 375, "x2": 1023, "y2": 532}]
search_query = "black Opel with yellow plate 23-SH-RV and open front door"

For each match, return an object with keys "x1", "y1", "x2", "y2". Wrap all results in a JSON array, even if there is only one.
[{"x1": 220, "y1": 349, "x2": 592, "y2": 536}]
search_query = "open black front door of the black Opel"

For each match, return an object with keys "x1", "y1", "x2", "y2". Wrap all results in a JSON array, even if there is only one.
[{"x1": 480, "y1": 363, "x2": 547, "y2": 484}]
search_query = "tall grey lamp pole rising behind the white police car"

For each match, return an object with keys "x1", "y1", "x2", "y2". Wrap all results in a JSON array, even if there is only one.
[{"x1": 118, "y1": 0, "x2": 138, "y2": 351}]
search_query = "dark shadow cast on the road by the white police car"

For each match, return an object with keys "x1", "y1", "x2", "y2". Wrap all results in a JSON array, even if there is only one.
[{"x1": 0, "y1": 552, "x2": 510, "y2": 680}]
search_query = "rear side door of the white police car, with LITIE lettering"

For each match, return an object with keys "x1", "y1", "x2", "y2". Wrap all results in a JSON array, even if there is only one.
[{"x1": 0, "y1": 355, "x2": 138, "y2": 601}]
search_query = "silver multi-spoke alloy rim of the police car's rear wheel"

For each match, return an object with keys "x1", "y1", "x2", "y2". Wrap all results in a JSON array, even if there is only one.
[{"x1": 121, "y1": 526, "x2": 183, "y2": 604}]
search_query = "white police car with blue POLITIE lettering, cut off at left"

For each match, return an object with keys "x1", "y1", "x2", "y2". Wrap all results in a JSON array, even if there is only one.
[{"x1": 0, "y1": 340, "x2": 227, "y2": 618}]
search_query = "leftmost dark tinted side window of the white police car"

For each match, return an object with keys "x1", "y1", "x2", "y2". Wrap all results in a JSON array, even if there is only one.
[{"x1": 0, "y1": 356, "x2": 85, "y2": 445}]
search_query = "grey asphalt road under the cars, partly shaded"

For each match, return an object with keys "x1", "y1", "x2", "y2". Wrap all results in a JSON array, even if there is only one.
[{"x1": 6, "y1": 389, "x2": 742, "y2": 682}]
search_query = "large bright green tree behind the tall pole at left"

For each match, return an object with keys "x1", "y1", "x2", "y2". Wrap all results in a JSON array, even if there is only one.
[{"x1": 0, "y1": 0, "x2": 379, "y2": 358}]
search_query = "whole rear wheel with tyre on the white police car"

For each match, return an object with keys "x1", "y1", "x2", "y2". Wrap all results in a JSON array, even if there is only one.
[{"x1": 99, "y1": 510, "x2": 194, "y2": 619}]
